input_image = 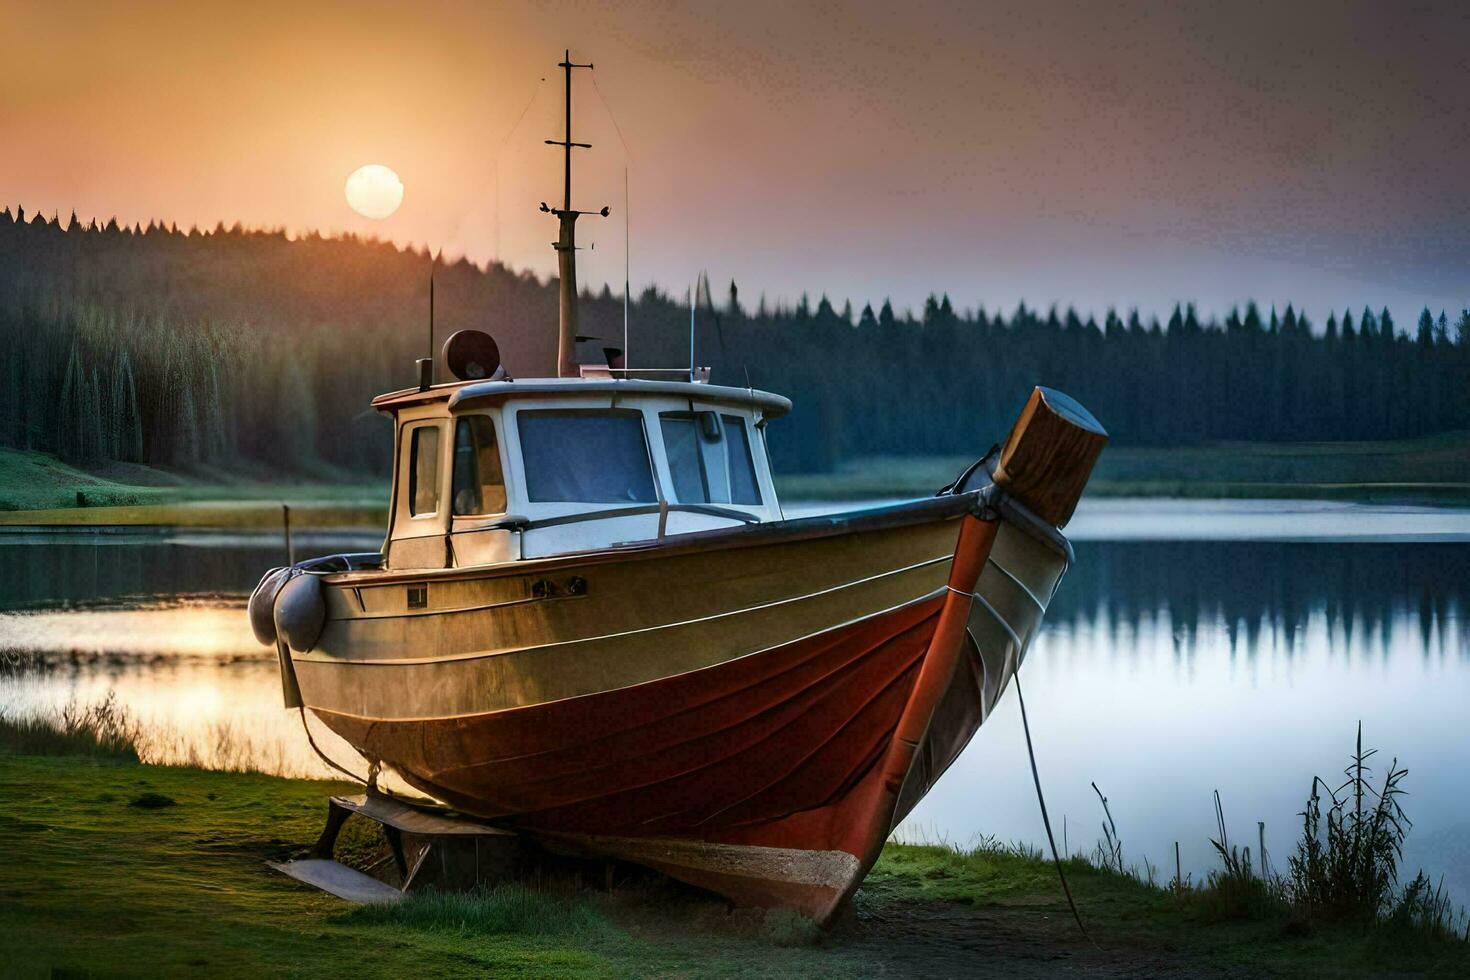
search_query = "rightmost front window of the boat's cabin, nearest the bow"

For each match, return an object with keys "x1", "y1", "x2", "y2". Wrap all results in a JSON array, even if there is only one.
[{"x1": 659, "y1": 411, "x2": 760, "y2": 505}]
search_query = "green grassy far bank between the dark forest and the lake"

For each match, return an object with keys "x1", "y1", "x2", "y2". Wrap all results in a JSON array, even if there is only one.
[{"x1": 0, "y1": 432, "x2": 1470, "y2": 527}]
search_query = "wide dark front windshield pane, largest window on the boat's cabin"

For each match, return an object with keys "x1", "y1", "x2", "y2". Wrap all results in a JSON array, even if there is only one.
[{"x1": 516, "y1": 408, "x2": 659, "y2": 504}]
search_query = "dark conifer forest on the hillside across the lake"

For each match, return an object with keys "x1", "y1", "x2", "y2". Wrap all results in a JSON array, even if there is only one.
[{"x1": 0, "y1": 209, "x2": 1470, "y2": 479}]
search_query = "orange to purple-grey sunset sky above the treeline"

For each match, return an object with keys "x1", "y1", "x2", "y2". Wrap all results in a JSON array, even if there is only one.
[{"x1": 0, "y1": 0, "x2": 1470, "y2": 328}]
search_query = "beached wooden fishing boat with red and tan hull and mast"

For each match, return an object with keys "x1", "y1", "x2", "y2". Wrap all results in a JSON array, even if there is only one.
[{"x1": 250, "y1": 54, "x2": 1107, "y2": 923}]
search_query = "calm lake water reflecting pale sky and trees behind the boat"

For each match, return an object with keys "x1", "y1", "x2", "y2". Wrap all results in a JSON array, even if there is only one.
[{"x1": 0, "y1": 501, "x2": 1470, "y2": 901}]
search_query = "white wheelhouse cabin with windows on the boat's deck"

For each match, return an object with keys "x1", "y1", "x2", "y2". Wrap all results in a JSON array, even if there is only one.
[{"x1": 373, "y1": 378, "x2": 791, "y2": 569}]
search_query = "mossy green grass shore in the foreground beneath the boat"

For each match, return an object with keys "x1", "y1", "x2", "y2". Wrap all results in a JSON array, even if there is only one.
[{"x1": 0, "y1": 751, "x2": 1470, "y2": 979}]
